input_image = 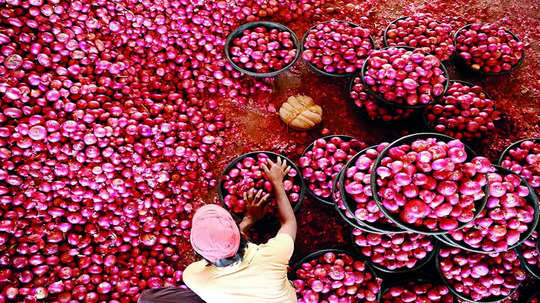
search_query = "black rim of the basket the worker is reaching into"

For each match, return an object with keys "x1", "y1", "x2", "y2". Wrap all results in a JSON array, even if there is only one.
[{"x1": 218, "y1": 151, "x2": 306, "y2": 218}]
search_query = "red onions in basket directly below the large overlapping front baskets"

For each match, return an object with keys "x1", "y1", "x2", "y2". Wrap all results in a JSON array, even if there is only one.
[{"x1": 352, "y1": 228, "x2": 435, "y2": 271}]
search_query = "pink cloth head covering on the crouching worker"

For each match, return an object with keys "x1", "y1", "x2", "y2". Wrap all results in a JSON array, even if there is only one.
[{"x1": 191, "y1": 204, "x2": 240, "y2": 263}]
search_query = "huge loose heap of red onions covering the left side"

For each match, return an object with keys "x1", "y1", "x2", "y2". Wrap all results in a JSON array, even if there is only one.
[{"x1": 0, "y1": 0, "x2": 324, "y2": 303}]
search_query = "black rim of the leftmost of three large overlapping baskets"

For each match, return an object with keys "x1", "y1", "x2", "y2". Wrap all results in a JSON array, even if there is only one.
[{"x1": 339, "y1": 145, "x2": 406, "y2": 233}]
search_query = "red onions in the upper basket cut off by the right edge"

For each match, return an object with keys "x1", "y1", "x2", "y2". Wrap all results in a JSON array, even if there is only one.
[{"x1": 501, "y1": 139, "x2": 540, "y2": 195}]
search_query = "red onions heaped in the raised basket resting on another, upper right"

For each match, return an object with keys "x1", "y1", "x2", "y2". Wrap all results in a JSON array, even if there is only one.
[{"x1": 362, "y1": 46, "x2": 448, "y2": 106}]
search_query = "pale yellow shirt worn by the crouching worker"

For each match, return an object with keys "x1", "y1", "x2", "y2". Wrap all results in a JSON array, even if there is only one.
[{"x1": 183, "y1": 234, "x2": 296, "y2": 303}]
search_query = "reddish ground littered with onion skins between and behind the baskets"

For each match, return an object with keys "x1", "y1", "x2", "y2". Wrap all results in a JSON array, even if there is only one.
[{"x1": 206, "y1": 0, "x2": 540, "y2": 300}]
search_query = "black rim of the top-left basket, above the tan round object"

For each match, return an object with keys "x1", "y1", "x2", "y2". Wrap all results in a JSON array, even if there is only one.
[{"x1": 224, "y1": 21, "x2": 302, "y2": 77}]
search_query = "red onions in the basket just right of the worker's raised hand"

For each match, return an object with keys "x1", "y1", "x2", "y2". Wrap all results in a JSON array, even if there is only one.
[{"x1": 298, "y1": 136, "x2": 367, "y2": 200}]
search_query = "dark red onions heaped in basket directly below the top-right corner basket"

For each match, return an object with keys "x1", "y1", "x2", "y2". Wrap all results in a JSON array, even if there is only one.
[{"x1": 424, "y1": 82, "x2": 500, "y2": 140}]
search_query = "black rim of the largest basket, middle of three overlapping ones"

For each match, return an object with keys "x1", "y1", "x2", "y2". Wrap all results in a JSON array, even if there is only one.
[{"x1": 371, "y1": 133, "x2": 489, "y2": 235}]
